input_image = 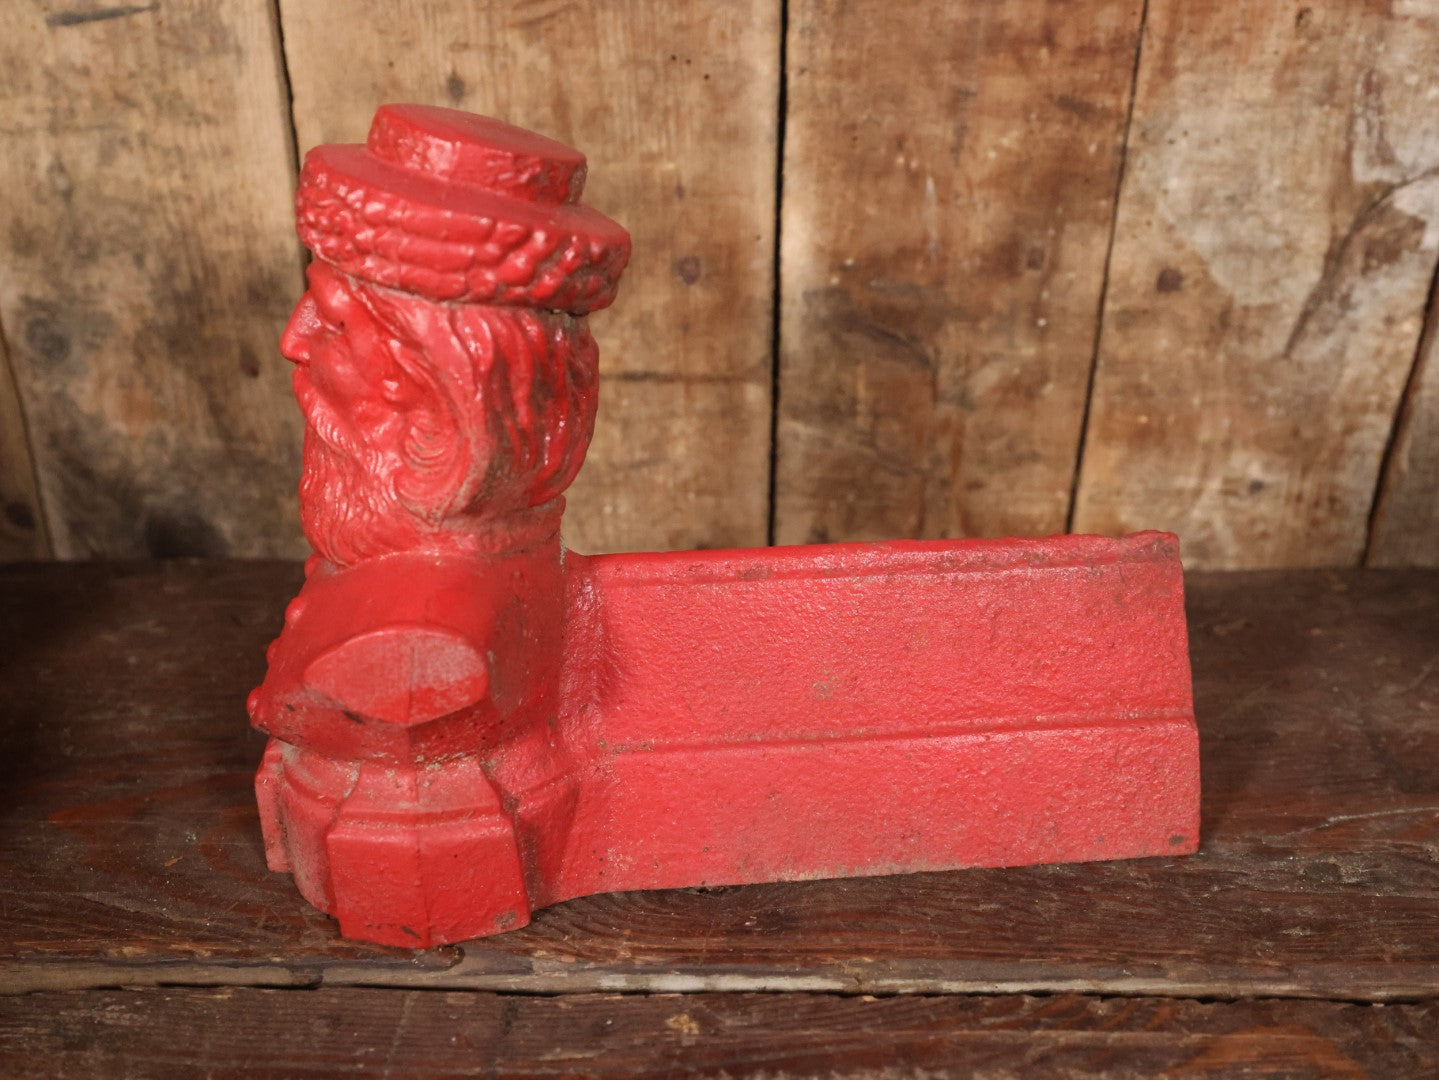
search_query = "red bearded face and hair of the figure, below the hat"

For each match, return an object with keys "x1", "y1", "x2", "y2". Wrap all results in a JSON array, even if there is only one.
[{"x1": 283, "y1": 270, "x2": 596, "y2": 565}]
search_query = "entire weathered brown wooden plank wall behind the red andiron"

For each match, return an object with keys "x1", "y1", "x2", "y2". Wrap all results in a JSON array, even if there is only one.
[{"x1": 0, "y1": 0, "x2": 1439, "y2": 567}]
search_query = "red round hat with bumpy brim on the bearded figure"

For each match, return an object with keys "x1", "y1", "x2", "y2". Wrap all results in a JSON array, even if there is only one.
[{"x1": 295, "y1": 105, "x2": 630, "y2": 315}]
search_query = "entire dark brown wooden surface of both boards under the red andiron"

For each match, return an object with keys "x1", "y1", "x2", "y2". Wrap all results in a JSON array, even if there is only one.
[{"x1": 0, "y1": 562, "x2": 1439, "y2": 1077}]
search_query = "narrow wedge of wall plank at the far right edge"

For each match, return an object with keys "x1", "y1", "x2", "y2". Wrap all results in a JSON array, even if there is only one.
[{"x1": 1367, "y1": 301, "x2": 1439, "y2": 567}]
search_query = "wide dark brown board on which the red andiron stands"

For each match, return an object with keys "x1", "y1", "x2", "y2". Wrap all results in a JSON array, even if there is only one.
[{"x1": 0, "y1": 562, "x2": 1439, "y2": 1001}]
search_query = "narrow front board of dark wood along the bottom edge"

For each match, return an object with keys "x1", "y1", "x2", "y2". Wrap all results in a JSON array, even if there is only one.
[{"x1": 0, "y1": 989, "x2": 1439, "y2": 1080}]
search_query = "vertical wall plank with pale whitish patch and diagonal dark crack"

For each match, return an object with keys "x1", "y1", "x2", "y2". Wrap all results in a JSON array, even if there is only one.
[{"x1": 1075, "y1": 0, "x2": 1439, "y2": 567}]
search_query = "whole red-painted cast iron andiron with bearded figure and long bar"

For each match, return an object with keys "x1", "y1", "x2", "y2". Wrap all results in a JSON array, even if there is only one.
[{"x1": 249, "y1": 105, "x2": 1199, "y2": 945}]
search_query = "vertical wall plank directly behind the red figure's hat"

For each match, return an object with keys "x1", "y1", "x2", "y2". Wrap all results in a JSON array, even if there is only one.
[{"x1": 281, "y1": 0, "x2": 780, "y2": 551}]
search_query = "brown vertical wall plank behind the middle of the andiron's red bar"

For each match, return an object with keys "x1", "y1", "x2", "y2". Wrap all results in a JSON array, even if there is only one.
[{"x1": 777, "y1": 0, "x2": 1141, "y2": 542}]
